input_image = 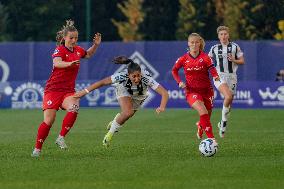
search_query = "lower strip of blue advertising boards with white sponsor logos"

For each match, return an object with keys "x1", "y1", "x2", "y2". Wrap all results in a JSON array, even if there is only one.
[{"x1": 0, "y1": 81, "x2": 284, "y2": 109}]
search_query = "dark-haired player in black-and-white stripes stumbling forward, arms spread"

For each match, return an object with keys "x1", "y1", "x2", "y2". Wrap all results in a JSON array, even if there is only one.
[{"x1": 74, "y1": 56, "x2": 169, "y2": 147}]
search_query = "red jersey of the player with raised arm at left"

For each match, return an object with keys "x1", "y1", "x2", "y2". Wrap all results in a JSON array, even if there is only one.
[{"x1": 44, "y1": 45, "x2": 86, "y2": 92}]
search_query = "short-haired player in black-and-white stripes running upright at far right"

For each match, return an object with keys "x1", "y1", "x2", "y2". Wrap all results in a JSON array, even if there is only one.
[{"x1": 209, "y1": 26, "x2": 245, "y2": 138}]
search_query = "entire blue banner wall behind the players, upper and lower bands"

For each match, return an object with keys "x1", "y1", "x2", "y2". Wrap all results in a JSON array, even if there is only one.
[{"x1": 0, "y1": 41, "x2": 284, "y2": 109}]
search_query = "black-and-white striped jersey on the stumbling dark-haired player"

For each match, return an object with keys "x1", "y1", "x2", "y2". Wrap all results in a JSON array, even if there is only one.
[{"x1": 111, "y1": 70, "x2": 159, "y2": 97}]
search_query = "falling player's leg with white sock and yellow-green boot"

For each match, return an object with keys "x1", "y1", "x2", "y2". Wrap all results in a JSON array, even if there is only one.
[{"x1": 103, "y1": 96, "x2": 136, "y2": 147}]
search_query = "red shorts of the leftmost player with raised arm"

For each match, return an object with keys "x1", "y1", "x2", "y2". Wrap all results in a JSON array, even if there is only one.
[{"x1": 42, "y1": 92, "x2": 75, "y2": 110}]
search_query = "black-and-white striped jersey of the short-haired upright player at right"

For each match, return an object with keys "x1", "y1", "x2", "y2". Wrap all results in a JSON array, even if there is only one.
[{"x1": 208, "y1": 42, "x2": 243, "y2": 75}]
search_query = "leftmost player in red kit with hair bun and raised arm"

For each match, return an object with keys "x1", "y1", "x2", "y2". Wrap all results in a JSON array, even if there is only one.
[{"x1": 32, "y1": 20, "x2": 101, "y2": 157}]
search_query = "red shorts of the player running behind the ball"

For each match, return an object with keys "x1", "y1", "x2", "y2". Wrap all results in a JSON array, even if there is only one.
[{"x1": 186, "y1": 89, "x2": 214, "y2": 110}]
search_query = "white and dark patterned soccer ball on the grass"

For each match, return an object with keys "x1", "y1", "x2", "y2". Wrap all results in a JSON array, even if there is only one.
[{"x1": 199, "y1": 138, "x2": 218, "y2": 157}]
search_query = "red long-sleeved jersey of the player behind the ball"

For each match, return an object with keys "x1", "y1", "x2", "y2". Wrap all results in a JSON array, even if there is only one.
[{"x1": 172, "y1": 52, "x2": 218, "y2": 92}]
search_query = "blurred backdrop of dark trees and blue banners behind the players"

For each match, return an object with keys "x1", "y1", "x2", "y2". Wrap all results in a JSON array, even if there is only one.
[{"x1": 0, "y1": 0, "x2": 284, "y2": 108}]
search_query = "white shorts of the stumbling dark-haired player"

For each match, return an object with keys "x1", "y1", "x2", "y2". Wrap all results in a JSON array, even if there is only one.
[{"x1": 116, "y1": 85, "x2": 148, "y2": 110}]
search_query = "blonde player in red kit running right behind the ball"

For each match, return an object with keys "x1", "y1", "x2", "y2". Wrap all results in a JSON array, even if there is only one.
[{"x1": 172, "y1": 33, "x2": 220, "y2": 139}]
